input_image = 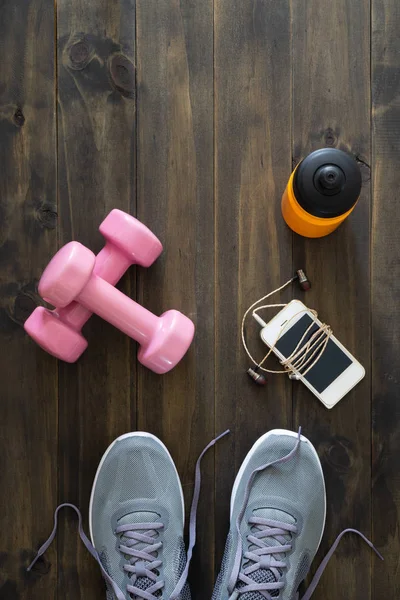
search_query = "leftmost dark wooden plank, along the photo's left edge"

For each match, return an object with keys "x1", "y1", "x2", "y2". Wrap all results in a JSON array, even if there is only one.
[{"x1": 0, "y1": 0, "x2": 58, "y2": 600}]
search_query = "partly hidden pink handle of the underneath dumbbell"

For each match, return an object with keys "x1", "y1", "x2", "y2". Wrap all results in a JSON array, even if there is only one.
[{"x1": 56, "y1": 242, "x2": 133, "y2": 331}]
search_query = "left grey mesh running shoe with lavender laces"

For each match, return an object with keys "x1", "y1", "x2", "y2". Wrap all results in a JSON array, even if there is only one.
[{"x1": 89, "y1": 433, "x2": 190, "y2": 600}]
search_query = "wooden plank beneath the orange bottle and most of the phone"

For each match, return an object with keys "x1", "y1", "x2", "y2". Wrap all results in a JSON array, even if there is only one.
[{"x1": 293, "y1": 0, "x2": 371, "y2": 600}]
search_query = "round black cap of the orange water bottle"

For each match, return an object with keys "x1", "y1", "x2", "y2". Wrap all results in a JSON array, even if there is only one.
[{"x1": 293, "y1": 148, "x2": 361, "y2": 219}]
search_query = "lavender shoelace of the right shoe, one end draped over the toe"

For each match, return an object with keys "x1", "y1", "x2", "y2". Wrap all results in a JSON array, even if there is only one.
[{"x1": 228, "y1": 427, "x2": 383, "y2": 600}]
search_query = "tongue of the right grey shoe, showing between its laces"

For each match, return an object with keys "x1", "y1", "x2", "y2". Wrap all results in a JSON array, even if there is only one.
[{"x1": 237, "y1": 508, "x2": 296, "y2": 600}]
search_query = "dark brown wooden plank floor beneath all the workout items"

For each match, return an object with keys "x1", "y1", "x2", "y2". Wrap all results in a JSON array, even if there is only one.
[{"x1": 0, "y1": 0, "x2": 400, "y2": 600}]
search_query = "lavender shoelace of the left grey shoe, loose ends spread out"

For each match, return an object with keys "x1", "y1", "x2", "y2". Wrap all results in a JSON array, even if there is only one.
[{"x1": 27, "y1": 429, "x2": 229, "y2": 600}]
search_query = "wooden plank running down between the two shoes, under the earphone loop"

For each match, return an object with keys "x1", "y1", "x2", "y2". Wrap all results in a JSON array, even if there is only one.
[{"x1": 215, "y1": 0, "x2": 292, "y2": 569}]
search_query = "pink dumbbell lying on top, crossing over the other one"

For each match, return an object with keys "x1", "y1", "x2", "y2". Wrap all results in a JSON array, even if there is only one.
[{"x1": 27, "y1": 242, "x2": 194, "y2": 373}]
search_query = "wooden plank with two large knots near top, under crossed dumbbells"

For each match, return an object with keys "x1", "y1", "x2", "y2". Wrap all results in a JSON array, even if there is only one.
[{"x1": 57, "y1": 0, "x2": 136, "y2": 599}]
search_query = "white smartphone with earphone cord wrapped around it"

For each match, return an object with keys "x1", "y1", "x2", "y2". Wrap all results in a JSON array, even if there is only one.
[{"x1": 260, "y1": 300, "x2": 365, "y2": 408}]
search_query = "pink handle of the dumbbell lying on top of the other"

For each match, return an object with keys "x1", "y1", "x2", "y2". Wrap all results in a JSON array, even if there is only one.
[{"x1": 77, "y1": 274, "x2": 160, "y2": 345}]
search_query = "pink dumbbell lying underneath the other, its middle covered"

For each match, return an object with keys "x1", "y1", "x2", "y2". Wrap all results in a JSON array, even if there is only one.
[{"x1": 24, "y1": 209, "x2": 163, "y2": 362}]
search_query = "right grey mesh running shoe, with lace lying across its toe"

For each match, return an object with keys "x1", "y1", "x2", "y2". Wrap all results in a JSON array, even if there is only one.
[{"x1": 212, "y1": 430, "x2": 325, "y2": 600}]
